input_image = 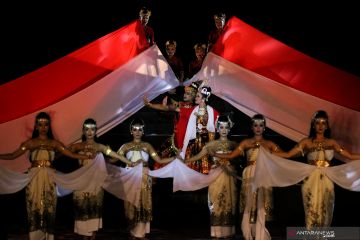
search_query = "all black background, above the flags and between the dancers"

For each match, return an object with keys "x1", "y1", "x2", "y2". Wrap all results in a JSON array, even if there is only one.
[{"x1": 0, "y1": 0, "x2": 360, "y2": 239}]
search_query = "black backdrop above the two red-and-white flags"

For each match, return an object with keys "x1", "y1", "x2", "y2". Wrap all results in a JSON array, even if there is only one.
[{"x1": 0, "y1": 0, "x2": 360, "y2": 83}]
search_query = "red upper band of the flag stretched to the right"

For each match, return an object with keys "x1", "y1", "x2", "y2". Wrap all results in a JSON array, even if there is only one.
[{"x1": 212, "y1": 17, "x2": 360, "y2": 111}]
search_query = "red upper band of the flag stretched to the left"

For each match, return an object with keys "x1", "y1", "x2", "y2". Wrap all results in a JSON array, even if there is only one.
[{"x1": 0, "y1": 20, "x2": 149, "y2": 123}]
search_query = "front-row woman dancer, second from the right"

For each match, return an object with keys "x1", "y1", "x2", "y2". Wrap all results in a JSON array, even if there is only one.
[{"x1": 212, "y1": 114, "x2": 280, "y2": 240}]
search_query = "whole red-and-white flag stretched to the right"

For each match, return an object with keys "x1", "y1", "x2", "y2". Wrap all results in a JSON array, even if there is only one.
[{"x1": 191, "y1": 18, "x2": 360, "y2": 152}]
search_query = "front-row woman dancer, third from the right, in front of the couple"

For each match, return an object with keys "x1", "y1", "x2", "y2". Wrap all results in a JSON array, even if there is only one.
[{"x1": 185, "y1": 116, "x2": 237, "y2": 238}]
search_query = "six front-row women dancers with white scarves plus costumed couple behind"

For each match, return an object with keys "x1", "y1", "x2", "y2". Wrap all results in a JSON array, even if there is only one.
[{"x1": 0, "y1": 83, "x2": 360, "y2": 240}]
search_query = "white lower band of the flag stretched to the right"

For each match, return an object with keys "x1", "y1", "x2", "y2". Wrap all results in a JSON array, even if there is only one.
[{"x1": 189, "y1": 52, "x2": 360, "y2": 152}]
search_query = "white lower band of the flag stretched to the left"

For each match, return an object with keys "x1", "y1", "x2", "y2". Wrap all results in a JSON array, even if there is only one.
[{"x1": 0, "y1": 45, "x2": 179, "y2": 172}]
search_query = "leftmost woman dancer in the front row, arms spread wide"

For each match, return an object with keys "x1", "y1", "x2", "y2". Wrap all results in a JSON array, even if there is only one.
[{"x1": 0, "y1": 112, "x2": 91, "y2": 240}]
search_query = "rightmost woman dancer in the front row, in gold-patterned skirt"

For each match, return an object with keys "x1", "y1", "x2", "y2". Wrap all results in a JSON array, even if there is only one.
[{"x1": 274, "y1": 110, "x2": 360, "y2": 229}]
